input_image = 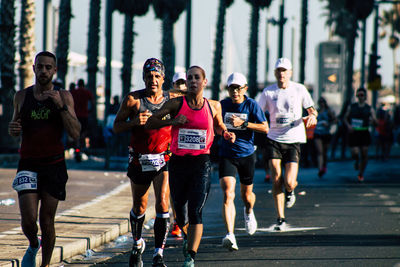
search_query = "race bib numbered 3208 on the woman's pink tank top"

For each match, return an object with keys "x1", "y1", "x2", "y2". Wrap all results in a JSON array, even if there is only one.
[{"x1": 178, "y1": 128, "x2": 207, "y2": 150}]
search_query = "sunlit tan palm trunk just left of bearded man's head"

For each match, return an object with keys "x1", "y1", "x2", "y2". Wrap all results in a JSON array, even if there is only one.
[{"x1": 18, "y1": 0, "x2": 35, "y2": 90}]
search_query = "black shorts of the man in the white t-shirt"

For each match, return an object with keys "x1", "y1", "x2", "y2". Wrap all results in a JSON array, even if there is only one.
[{"x1": 265, "y1": 138, "x2": 300, "y2": 163}]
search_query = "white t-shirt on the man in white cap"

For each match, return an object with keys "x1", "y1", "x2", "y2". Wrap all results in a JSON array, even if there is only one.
[{"x1": 258, "y1": 81, "x2": 314, "y2": 144}]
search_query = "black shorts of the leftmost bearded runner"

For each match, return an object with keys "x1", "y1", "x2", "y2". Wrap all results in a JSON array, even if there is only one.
[{"x1": 17, "y1": 159, "x2": 68, "y2": 200}]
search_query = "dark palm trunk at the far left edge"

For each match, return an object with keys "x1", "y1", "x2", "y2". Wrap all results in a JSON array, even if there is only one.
[{"x1": 0, "y1": 0, "x2": 18, "y2": 151}]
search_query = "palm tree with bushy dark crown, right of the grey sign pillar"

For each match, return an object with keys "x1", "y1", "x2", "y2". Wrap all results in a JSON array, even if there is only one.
[{"x1": 325, "y1": 0, "x2": 374, "y2": 103}]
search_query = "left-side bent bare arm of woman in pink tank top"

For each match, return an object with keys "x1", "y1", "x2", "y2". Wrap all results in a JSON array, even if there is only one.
[{"x1": 145, "y1": 98, "x2": 187, "y2": 129}]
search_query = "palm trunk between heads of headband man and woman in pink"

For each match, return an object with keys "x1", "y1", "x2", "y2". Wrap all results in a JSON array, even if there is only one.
[{"x1": 161, "y1": 12, "x2": 175, "y2": 90}]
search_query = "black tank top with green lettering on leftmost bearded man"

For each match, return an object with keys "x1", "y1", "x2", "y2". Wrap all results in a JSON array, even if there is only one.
[{"x1": 20, "y1": 86, "x2": 64, "y2": 161}]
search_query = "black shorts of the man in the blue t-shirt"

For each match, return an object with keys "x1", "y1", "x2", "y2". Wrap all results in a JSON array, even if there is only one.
[{"x1": 219, "y1": 153, "x2": 256, "y2": 185}]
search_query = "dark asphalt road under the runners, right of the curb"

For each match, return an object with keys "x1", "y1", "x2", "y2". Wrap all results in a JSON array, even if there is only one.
[{"x1": 53, "y1": 158, "x2": 400, "y2": 267}]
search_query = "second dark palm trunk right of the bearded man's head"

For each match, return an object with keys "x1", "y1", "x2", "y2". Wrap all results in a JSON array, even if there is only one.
[{"x1": 86, "y1": 0, "x2": 101, "y2": 125}]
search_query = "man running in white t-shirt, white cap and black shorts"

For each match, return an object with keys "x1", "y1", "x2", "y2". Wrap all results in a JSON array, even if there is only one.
[{"x1": 258, "y1": 58, "x2": 318, "y2": 230}]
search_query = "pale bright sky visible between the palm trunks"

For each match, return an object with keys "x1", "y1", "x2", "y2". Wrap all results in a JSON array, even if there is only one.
[{"x1": 25, "y1": 0, "x2": 398, "y2": 99}]
